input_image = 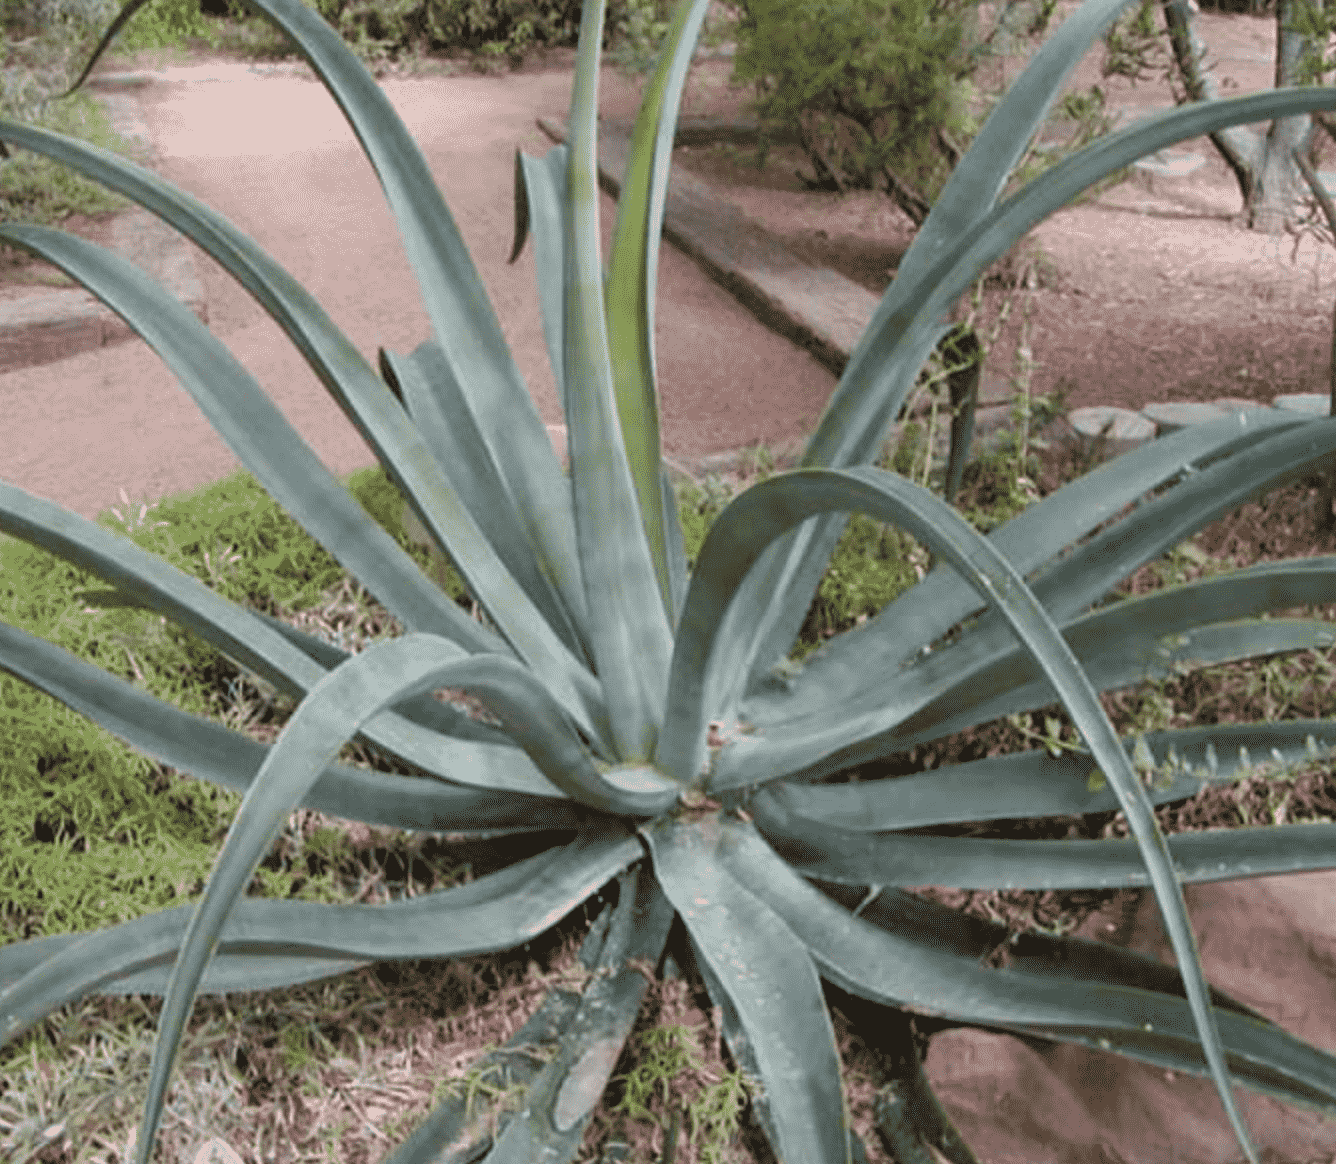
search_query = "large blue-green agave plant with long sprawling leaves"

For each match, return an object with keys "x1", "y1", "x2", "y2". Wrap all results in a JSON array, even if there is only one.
[{"x1": 0, "y1": 0, "x2": 1336, "y2": 1164}]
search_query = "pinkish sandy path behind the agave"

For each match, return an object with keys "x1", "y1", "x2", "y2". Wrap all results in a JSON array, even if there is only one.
[{"x1": 0, "y1": 59, "x2": 835, "y2": 516}]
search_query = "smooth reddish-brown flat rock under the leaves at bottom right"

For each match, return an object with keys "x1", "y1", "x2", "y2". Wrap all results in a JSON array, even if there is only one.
[{"x1": 925, "y1": 871, "x2": 1336, "y2": 1164}]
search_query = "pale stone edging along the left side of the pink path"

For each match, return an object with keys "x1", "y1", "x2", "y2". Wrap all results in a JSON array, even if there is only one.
[{"x1": 0, "y1": 85, "x2": 208, "y2": 373}]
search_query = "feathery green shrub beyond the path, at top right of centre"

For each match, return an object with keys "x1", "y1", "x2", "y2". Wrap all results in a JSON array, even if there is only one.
[{"x1": 733, "y1": 0, "x2": 1129, "y2": 227}]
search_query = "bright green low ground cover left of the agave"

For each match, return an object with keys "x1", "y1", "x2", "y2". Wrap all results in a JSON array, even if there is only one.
[{"x1": 0, "y1": 457, "x2": 462, "y2": 943}]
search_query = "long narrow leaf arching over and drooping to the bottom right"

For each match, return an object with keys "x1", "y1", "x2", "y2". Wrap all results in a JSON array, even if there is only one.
[{"x1": 659, "y1": 468, "x2": 1255, "y2": 1159}]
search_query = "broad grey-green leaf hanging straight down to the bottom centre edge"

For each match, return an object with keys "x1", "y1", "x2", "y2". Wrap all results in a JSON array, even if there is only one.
[{"x1": 641, "y1": 815, "x2": 848, "y2": 1164}]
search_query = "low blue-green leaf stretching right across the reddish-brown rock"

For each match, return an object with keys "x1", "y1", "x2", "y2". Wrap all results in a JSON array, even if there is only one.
[{"x1": 724, "y1": 834, "x2": 1336, "y2": 1113}]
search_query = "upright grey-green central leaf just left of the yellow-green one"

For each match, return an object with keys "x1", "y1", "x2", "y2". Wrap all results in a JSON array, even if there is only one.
[{"x1": 562, "y1": 0, "x2": 672, "y2": 762}]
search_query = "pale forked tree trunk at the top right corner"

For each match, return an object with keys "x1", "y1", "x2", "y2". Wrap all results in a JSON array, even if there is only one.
[{"x1": 1162, "y1": 0, "x2": 1321, "y2": 234}]
